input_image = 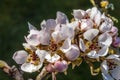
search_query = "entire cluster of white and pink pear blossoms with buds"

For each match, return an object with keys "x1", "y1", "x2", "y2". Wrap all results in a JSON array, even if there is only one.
[{"x1": 13, "y1": 7, "x2": 120, "y2": 80}]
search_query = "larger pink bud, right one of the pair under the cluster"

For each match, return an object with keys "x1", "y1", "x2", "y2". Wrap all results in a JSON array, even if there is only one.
[{"x1": 54, "y1": 60, "x2": 68, "y2": 72}]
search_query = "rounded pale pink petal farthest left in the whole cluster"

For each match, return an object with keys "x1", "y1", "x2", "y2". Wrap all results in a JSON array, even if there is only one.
[{"x1": 12, "y1": 50, "x2": 28, "y2": 64}]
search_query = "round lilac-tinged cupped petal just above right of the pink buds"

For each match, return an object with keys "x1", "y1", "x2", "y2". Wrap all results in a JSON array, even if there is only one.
[{"x1": 65, "y1": 45, "x2": 80, "y2": 61}]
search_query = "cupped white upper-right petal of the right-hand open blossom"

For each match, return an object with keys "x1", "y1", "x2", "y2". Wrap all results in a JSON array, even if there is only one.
[{"x1": 98, "y1": 32, "x2": 112, "y2": 47}]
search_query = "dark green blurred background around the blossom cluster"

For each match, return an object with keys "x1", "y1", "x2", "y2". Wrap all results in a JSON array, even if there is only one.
[{"x1": 0, "y1": 0, "x2": 120, "y2": 80}]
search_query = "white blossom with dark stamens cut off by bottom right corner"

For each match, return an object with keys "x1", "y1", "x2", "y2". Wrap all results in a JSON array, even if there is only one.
[{"x1": 101, "y1": 54, "x2": 120, "y2": 80}]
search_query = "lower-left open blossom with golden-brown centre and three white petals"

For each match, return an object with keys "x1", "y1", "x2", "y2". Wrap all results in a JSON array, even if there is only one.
[{"x1": 13, "y1": 49, "x2": 48, "y2": 73}]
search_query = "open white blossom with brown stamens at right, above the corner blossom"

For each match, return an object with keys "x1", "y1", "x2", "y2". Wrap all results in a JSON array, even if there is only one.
[{"x1": 82, "y1": 29, "x2": 112, "y2": 58}]
